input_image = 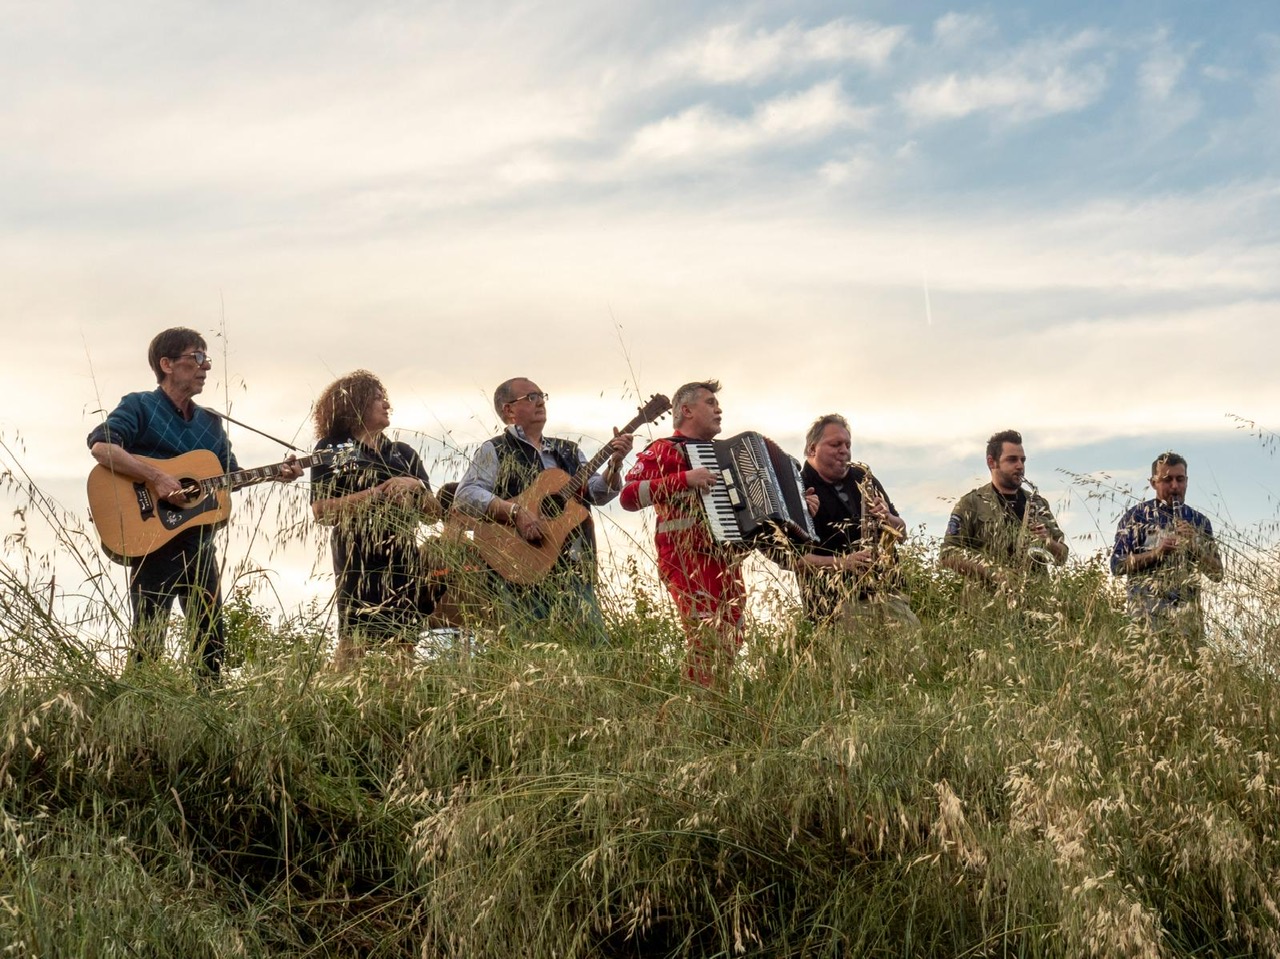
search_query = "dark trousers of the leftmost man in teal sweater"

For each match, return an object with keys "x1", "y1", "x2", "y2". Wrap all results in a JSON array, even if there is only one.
[{"x1": 129, "y1": 530, "x2": 225, "y2": 680}]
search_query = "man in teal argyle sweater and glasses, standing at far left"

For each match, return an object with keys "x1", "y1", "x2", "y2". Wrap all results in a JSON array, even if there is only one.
[{"x1": 88, "y1": 326, "x2": 302, "y2": 684}]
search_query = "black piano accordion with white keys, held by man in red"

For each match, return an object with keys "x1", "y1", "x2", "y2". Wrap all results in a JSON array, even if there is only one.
[{"x1": 685, "y1": 433, "x2": 818, "y2": 545}]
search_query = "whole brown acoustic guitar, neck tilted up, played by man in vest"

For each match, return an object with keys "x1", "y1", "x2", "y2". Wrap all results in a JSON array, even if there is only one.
[{"x1": 445, "y1": 393, "x2": 671, "y2": 586}]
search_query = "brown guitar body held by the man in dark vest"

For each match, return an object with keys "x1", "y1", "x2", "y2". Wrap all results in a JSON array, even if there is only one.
[{"x1": 457, "y1": 470, "x2": 588, "y2": 586}]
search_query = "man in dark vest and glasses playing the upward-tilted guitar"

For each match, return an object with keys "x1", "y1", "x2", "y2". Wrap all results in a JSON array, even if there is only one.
[{"x1": 453, "y1": 376, "x2": 634, "y2": 645}]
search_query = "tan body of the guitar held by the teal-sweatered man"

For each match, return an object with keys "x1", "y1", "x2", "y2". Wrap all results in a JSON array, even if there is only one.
[{"x1": 88, "y1": 449, "x2": 232, "y2": 562}]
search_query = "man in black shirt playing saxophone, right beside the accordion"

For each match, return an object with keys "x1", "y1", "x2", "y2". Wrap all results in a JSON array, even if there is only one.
[{"x1": 796, "y1": 414, "x2": 920, "y2": 627}]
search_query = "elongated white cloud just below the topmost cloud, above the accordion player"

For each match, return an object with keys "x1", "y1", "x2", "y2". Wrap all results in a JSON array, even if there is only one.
[{"x1": 628, "y1": 81, "x2": 873, "y2": 161}]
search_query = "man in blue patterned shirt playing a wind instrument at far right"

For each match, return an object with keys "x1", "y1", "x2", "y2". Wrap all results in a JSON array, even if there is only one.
[{"x1": 1111, "y1": 452, "x2": 1222, "y2": 644}]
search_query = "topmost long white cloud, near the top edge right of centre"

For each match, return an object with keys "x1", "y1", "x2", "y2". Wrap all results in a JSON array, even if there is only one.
[{"x1": 662, "y1": 19, "x2": 906, "y2": 83}]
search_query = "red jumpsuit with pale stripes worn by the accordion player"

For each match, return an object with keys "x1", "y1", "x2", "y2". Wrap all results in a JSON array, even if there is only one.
[{"x1": 618, "y1": 430, "x2": 745, "y2": 686}]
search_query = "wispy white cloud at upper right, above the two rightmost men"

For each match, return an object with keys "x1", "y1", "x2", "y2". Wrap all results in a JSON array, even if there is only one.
[{"x1": 899, "y1": 31, "x2": 1107, "y2": 122}]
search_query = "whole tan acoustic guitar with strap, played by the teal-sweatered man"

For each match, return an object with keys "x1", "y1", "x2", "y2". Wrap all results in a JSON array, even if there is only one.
[{"x1": 88, "y1": 443, "x2": 355, "y2": 563}]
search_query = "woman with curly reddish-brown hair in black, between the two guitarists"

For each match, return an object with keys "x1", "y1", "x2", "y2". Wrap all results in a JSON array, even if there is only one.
[{"x1": 311, "y1": 370, "x2": 442, "y2": 668}]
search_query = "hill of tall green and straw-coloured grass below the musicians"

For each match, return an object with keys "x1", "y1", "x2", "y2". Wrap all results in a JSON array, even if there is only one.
[{"x1": 0, "y1": 553, "x2": 1280, "y2": 959}]
